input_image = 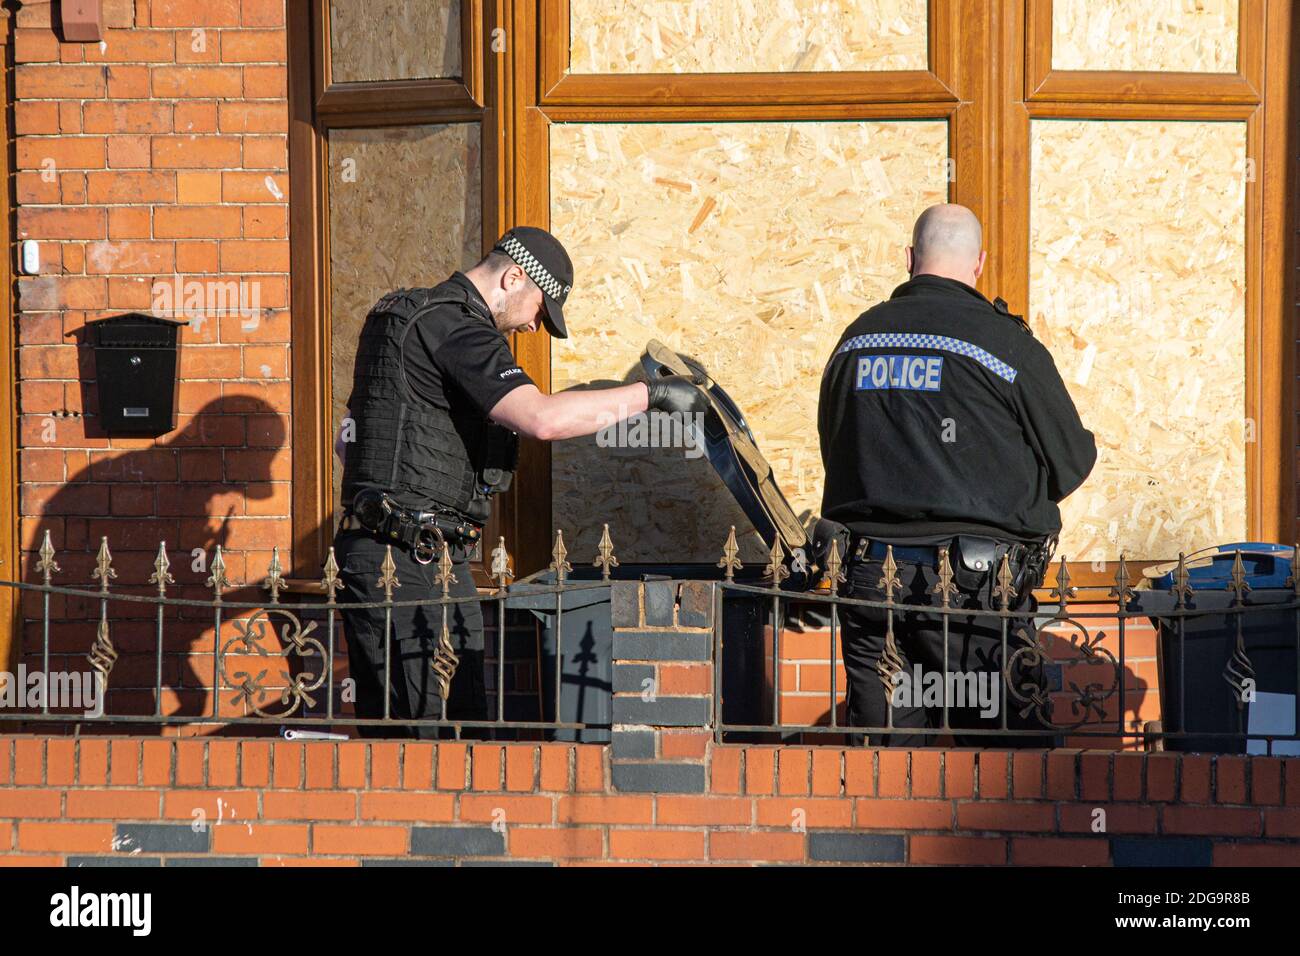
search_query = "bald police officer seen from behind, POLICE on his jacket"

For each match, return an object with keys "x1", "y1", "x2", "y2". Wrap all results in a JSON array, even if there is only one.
[{"x1": 818, "y1": 204, "x2": 1097, "y2": 747}]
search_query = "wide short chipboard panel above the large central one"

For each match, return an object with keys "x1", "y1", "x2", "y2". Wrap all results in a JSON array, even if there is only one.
[{"x1": 569, "y1": 0, "x2": 928, "y2": 73}]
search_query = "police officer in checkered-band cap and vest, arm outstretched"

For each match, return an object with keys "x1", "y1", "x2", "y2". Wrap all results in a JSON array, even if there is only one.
[{"x1": 334, "y1": 226, "x2": 706, "y2": 737}]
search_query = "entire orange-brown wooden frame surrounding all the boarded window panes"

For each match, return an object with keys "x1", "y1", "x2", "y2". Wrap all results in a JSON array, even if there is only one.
[{"x1": 290, "y1": 0, "x2": 1300, "y2": 581}]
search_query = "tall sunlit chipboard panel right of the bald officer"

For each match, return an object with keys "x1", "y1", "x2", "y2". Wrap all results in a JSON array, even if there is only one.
[{"x1": 1030, "y1": 120, "x2": 1247, "y2": 561}]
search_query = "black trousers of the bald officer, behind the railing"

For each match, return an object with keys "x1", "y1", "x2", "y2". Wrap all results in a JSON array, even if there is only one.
[{"x1": 841, "y1": 559, "x2": 1053, "y2": 748}]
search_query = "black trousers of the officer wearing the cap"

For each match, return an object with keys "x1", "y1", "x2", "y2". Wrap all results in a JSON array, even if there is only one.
[{"x1": 334, "y1": 531, "x2": 488, "y2": 739}]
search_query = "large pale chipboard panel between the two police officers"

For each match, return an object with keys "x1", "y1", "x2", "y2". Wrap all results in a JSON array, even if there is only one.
[{"x1": 550, "y1": 121, "x2": 948, "y2": 562}]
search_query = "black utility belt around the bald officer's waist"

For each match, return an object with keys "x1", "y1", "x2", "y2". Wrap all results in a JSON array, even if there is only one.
[{"x1": 814, "y1": 519, "x2": 1057, "y2": 596}]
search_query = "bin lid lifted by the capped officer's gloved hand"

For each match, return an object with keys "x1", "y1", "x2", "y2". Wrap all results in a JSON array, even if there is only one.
[{"x1": 641, "y1": 339, "x2": 810, "y2": 567}]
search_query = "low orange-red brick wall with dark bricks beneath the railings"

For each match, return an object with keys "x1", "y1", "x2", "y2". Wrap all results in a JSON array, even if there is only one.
[{"x1": 0, "y1": 730, "x2": 1300, "y2": 866}]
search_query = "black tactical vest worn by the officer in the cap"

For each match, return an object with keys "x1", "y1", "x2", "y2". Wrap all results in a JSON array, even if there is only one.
[{"x1": 343, "y1": 284, "x2": 491, "y2": 514}]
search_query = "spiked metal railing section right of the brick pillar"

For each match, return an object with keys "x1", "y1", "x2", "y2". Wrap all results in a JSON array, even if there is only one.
[{"x1": 714, "y1": 540, "x2": 1300, "y2": 753}]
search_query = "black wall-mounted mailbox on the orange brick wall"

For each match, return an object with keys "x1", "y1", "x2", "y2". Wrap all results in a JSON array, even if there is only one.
[{"x1": 86, "y1": 312, "x2": 185, "y2": 434}]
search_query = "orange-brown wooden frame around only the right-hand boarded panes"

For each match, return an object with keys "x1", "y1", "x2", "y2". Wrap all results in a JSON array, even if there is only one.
[{"x1": 991, "y1": 0, "x2": 1300, "y2": 584}]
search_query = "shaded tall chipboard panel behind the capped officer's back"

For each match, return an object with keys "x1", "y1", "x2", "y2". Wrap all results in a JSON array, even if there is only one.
[{"x1": 329, "y1": 124, "x2": 482, "y2": 515}]
